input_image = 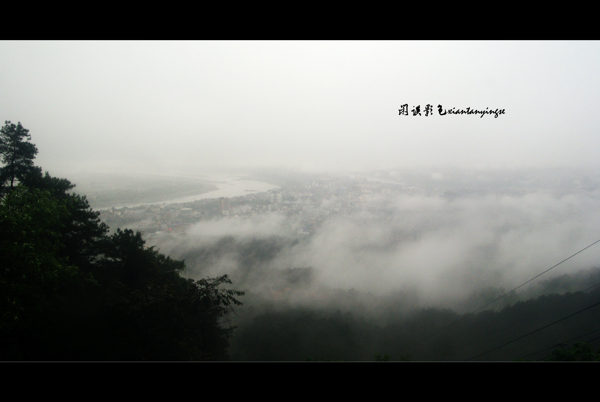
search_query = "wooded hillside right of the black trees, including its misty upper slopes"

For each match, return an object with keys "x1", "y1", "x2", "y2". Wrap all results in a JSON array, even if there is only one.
[{"x1": 164, "y1": 236, "x2": 600, "y2": 361}]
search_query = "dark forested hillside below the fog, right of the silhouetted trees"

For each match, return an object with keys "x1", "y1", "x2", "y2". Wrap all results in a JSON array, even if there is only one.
[{"x1": 227, "y1": 282, "x2": 600, "y2": 361}]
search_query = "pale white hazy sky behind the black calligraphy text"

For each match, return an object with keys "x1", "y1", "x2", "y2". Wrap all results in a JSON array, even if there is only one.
[{"x1": 0, "y1": 41, "x2": 600, "y2": 174}]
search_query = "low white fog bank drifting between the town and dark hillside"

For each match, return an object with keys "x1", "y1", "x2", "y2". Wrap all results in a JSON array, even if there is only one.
[{"x1": 154, "y1": 187, "x2": 600, "y2": 310}]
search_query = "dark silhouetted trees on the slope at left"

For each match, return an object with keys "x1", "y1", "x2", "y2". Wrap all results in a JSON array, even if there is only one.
[{"x1": 0, "y1": 122, "x2": 243, "y2": 360}]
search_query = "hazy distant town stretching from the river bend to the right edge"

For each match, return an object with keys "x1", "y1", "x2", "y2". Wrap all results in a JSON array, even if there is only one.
[{"x1": 94, "y1": 167, "x2": 600, "y2": 239}]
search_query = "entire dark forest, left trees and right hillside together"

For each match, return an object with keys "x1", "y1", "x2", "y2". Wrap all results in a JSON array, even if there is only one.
[{"x1": 0, "y1": 122, "x2": 600, "y2": 361}]
